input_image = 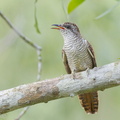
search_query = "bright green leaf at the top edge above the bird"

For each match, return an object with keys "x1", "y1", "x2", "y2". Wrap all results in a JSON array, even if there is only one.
[{"x1": 68, "y1": 0, "x2": 85, "y2": 14}]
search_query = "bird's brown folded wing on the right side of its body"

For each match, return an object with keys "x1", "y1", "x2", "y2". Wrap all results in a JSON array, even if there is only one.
[{"x1": 87, "y1": 41, "x2": 97, "y2": 68}]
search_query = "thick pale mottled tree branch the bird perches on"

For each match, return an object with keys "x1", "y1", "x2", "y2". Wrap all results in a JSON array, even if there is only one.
[{"x1": 0, "y1": 62, "x2": 120, "y2": 114}]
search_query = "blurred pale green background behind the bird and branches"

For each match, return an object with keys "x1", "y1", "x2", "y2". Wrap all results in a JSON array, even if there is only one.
[{"x1": 0, "y1": 0, "x2": 120, "y2": 120}]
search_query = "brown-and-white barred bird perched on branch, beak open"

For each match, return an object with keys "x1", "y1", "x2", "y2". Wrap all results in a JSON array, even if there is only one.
[{"x1": 52, "y1": 22, "x2": 98, "y2": 114}]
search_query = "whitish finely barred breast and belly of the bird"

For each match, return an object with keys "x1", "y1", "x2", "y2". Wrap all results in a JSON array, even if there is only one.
[{"x1": 63, "y1": 39, "x2": 93, "y2": 72}]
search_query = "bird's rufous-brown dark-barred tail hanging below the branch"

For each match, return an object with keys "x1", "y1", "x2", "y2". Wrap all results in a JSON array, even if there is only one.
[{"x1": 79, "y1": 92, "x2": 98, "y2": 114}]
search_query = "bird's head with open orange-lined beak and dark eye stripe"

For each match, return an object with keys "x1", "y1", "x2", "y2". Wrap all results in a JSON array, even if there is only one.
[{"x1": 52, "y1": 22, "x2": 80, "y2": 38}]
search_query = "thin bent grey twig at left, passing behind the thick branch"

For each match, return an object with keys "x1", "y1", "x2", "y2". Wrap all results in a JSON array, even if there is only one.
[{"x1": 0, "y1": 11, "x2": 42, "y2": 120}]
